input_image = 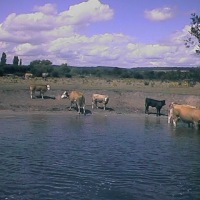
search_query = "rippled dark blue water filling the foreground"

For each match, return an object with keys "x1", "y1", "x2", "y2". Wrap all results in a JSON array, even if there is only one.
[{"x1": 0, "y1": 114, "x2": 200, "y2": 200}]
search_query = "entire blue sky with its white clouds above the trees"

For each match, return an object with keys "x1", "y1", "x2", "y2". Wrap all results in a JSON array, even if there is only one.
[{"x1": 0, "y1": 0, "x2": 200, "y2": 68}]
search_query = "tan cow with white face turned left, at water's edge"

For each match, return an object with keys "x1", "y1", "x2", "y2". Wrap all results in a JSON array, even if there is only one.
[{"x1": 61, "y1": 91, "x2": 85, "y2": 114}]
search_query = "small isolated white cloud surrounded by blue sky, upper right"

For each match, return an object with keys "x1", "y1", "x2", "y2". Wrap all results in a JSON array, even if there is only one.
[{"x1": 144, "y1": 7, "x2": 175, "y2": 21}]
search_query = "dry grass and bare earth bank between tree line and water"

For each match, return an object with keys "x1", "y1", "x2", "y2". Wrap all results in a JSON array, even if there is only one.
[{"x1": 0, "y1": 77, "x2": 200, "y2": 115}]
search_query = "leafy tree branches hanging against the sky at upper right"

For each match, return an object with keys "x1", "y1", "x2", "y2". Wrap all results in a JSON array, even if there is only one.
[{"x1": 185, "y1": 13, "x2": 200, "y2": 55}]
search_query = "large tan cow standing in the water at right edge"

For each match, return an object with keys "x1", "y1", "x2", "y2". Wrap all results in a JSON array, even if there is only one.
[{"x1": 168, "y1": 103, "x2": 200, "y2": 128}]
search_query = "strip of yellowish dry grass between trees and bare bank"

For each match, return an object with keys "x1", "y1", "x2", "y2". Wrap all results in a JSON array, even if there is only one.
[{"x1": 0, "y1": 77, "x2": 200, "y2": 95}]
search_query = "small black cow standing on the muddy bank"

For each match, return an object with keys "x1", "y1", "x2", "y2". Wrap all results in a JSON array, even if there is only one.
[{"x1": 145, "y1": 98, "x2": 165, "y2": 116}]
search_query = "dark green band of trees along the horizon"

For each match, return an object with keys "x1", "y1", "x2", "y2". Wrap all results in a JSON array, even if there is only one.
[{"x1": 0, "y1": 57, "x2": 200, "y2": 82}]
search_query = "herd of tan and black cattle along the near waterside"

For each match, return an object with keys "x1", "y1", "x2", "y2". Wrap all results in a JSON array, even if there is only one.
[{"x1": 30, "y1": 84, "x2": 200, "y2": 128}]
